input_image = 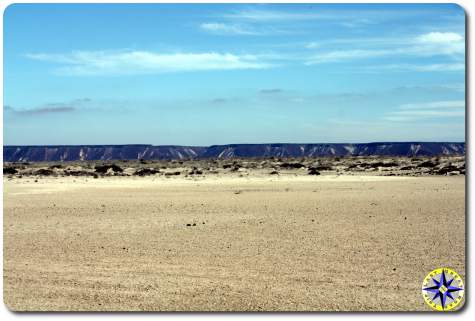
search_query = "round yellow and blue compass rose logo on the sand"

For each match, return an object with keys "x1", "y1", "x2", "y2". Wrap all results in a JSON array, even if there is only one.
[{"x1": 422, "y1": 268, "x2": 464, "y2": 311}]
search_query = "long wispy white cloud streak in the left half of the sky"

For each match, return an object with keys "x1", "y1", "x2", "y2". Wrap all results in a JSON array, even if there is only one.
[{"x1": 26, "y1": 51, "x2": 274, "y2": 75}]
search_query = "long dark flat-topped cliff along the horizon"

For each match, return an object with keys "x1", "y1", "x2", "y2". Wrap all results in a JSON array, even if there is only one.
[{"x1": 3, "y1": 143, "x2": 465, "y2": 162}]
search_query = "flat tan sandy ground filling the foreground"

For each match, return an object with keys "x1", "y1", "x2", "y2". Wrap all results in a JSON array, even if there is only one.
[{"x1": 4, "y1": 176, "x2": 465, "y2": 311}]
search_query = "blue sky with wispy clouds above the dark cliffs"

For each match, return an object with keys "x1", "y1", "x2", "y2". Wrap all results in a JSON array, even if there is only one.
[{"x1": 3, "y1": 4, "x2": 465, "y2": 145}]
